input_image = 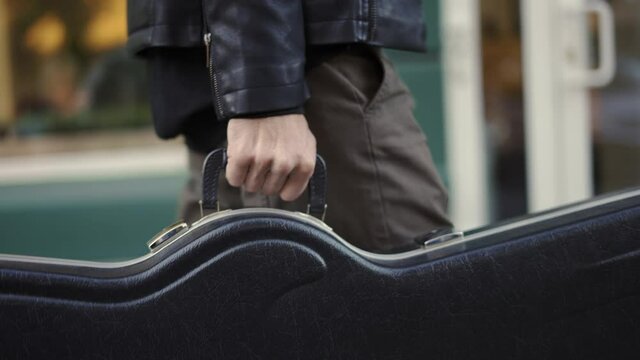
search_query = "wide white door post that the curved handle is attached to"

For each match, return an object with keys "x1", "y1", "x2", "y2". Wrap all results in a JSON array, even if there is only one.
[{"x1": 521, "y1": 0, "x2": 593, "y2": 211}]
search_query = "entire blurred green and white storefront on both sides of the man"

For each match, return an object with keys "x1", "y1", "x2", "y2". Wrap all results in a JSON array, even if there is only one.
[{"x1": 0, "y1": 0, "x2": 640, "y2": 261}]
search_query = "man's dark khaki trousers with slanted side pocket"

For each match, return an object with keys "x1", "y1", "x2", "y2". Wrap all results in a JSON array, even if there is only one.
[{"x1": 180, "y1": 47, "x2": 452, "y2": 253}]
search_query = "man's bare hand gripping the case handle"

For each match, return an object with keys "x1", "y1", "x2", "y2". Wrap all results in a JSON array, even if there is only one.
[{"x1": 227, "y1": 115, "x2": 316, "y2": 201}]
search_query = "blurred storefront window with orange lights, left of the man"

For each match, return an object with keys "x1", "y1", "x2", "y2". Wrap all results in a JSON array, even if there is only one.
[{"x1": 0, "y1": 0, "x2": 149, "y2": 137}]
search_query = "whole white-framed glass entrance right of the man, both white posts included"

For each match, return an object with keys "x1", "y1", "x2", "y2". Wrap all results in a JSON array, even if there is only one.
[{"x1": 442, "y1": 0, "x2": 640, "y2": 229}]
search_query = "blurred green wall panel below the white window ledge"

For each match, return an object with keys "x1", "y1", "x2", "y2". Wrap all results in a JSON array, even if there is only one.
[{"x1": 0, "y1": 175, "x2": 184, "y2": 261}]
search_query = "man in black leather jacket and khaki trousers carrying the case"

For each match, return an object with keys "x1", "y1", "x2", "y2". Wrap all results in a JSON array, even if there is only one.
[{"x1": 129, "y1": 0, "x2": 451, "y2": 252}]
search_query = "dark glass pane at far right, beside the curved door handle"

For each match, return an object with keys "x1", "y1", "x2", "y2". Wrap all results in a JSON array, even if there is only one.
[{"x1": 589, "y1": 0, "x2": 640, "y2": 194}]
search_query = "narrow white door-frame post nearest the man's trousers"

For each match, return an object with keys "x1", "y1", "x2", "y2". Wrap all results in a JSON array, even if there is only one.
[{"x1": 440, "y1": 0, "x2": 490, "y2": 229}]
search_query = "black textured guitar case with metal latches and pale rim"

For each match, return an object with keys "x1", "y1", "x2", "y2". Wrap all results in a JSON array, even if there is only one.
[{"x1": 0, "y1": 148, "x2": 640, "y2": 359}]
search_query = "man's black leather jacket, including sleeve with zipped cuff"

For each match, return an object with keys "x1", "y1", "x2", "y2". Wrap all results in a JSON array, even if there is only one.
[{"x1": 128, "y1": 0, "x2": 425, "y2": 120}]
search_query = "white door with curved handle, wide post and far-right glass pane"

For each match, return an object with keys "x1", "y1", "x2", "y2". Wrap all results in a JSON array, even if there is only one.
[{"x1": 521, "y1": 0, "x2": 640, "y2": 210}]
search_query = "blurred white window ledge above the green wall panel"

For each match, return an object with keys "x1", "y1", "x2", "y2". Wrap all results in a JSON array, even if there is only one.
[{"x1": 0, "y1": 130, "x2": 187, "y2": 185}]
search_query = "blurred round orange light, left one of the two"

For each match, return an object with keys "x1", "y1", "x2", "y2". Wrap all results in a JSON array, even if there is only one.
[{"x1": 24, "y1": 13, "x2": 67, "y2": 56}]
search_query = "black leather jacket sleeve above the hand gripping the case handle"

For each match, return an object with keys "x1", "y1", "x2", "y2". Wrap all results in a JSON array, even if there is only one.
[{"x1": 202, "y1": 0, "x2": 309, "y2": 120}]
